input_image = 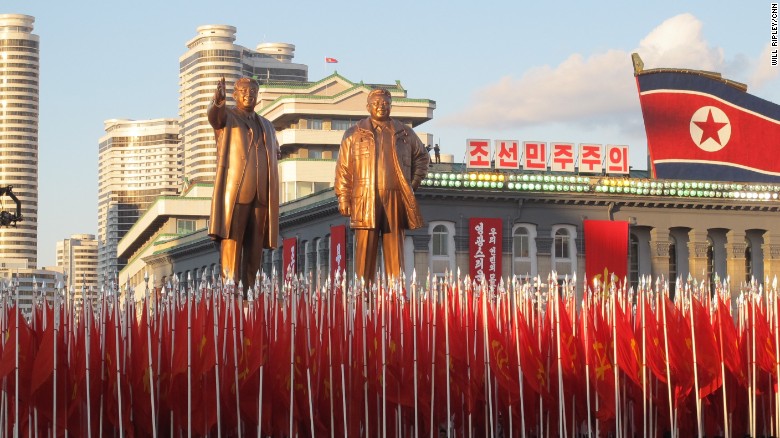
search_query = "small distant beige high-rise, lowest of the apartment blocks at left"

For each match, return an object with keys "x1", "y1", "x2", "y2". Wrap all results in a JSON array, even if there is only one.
[{"x1": 57, "y1": 234, "x2": 98, "y2": 302}]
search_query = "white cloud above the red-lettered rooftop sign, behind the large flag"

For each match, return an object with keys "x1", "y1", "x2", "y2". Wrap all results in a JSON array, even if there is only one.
[{"x1": 441, "y1": 14, "x2": 724, "y2": 130}]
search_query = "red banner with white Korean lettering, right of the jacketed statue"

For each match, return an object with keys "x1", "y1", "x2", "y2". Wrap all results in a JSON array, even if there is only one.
[{"x1": 469, "y1": 217, "x2": 502, "y2": 287}]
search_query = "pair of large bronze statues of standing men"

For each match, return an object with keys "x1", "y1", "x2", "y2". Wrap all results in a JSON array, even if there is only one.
[{"x1": 208, "y1": 78, "x2": 430, "y2": 286}]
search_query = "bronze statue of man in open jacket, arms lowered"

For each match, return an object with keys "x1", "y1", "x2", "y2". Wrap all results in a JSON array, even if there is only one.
[{"x1": 334, "y1": 89, "x2": 430, "y2": 282}]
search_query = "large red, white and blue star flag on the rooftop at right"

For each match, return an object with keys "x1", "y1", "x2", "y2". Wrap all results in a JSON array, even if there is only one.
[{"x1": 636, "y1": 71, "x2": 780, "y2": 182}]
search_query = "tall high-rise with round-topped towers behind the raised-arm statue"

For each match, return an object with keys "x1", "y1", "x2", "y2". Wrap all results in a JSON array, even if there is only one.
[{"x1": 179, "y1": 25, "x2": 308, "y2": 183}]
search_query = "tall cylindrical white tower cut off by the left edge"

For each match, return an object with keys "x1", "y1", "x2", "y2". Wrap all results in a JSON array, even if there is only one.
[{"x1": 0, "y1": 14, "x2": 39, "y2": 268}]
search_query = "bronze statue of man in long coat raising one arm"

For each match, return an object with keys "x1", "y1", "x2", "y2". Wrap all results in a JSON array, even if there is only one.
[{"x1": 208, "y1": 77, "x2": 279, "y2": 287}]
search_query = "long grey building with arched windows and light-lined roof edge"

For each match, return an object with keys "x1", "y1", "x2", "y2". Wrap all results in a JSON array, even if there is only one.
[{"x1": 266, "y1": 164, "x2": 780, "y2": 293}]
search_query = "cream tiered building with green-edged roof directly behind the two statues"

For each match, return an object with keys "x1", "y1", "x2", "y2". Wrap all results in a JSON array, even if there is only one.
[{"x1": 257, "y1": 73, "x2": 436, "y2": 202}]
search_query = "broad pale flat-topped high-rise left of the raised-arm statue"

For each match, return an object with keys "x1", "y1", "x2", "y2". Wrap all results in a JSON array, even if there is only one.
[{"x1": 98, "y1": 119, "x2": 181, "y2": 280}]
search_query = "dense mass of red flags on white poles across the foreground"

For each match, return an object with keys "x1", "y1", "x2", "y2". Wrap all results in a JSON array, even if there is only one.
[{"x1": 0, "y1": 277, "x2": 780, "y2": 437}]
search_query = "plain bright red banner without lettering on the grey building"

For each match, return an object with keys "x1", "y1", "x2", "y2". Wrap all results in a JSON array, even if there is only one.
[{"x1": 583, "y1": 220, "x2": 628, "y2": 284}]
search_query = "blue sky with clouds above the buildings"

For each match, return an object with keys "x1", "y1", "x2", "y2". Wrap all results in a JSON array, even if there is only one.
[{"x1": 0, "y1": 0, "x2": 780, "y2": 266}]
